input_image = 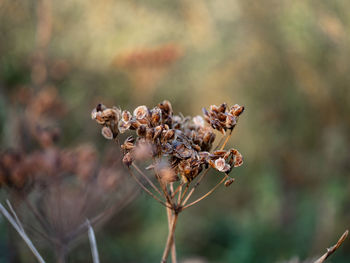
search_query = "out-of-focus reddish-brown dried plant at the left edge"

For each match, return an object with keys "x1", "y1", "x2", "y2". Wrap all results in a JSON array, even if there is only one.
[{"x1": 0, "y1": 87, "x2": 138, "y2": 262}]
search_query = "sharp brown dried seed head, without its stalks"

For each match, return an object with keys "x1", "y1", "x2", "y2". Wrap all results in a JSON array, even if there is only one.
[{"x1": 91, "y1": 100, "x2": 244, "y2": 182}]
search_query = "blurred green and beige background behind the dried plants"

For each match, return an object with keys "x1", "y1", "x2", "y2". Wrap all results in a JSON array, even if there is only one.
[{"x1": 0, "y1": 0, "x2": 350, "y2": 263}]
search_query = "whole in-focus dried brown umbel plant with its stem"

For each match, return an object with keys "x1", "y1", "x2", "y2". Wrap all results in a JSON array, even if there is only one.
[{"x1": 91, "y1": 101, "x2": 244, "y2": 263}]
